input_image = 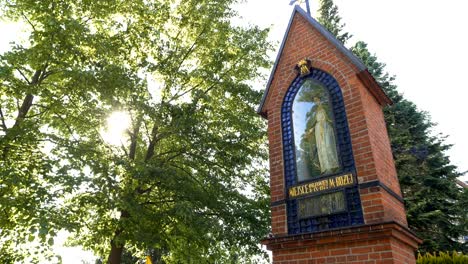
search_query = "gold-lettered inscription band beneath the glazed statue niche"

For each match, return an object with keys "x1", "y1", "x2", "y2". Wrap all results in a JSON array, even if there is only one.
[{"x1": 289, "y1": 173, "x2": 354, "y2": 198}]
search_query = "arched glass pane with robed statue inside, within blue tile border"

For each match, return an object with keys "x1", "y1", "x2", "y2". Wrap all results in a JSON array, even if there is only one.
[{"x1": 292, "y1": 79, "x2": 341, "y2": 182}]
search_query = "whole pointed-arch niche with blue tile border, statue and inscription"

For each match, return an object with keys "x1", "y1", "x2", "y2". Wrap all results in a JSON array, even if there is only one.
[{"x1": 281, "y1": 68, "x2": 364, "y2": 234}]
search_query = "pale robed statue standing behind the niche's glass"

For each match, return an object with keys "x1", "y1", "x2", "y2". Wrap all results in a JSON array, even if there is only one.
[{"x1": 306, "y1": 96, "x2": 339, "y2": 174}]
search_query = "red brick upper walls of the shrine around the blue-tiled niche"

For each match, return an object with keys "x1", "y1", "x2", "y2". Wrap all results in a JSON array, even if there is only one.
[{"x1": 264, "y1": 11, "x2": 407, "y2": 231}]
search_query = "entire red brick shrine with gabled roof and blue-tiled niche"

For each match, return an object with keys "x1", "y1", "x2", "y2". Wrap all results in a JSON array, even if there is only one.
[{"x1": 258, "y1": 6, "x2": 421, "y2": 263}]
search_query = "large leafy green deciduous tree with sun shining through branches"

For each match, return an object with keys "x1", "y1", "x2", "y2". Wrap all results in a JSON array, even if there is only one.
[{"x1": 0, "y1": 0, "x2": 270, "y2": 263}]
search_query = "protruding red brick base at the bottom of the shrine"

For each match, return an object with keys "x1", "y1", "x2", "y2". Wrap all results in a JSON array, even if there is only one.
[{"x1": 263, "y1": 223, "x2": 418, "y2": 264}]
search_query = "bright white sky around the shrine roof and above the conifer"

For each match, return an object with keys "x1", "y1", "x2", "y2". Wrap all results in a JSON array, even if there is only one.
[{"x1": 0, "y1": 0, "x2": 468, "y2": 263}]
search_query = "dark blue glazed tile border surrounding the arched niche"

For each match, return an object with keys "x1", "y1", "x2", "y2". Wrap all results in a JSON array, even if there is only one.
[{"x1": 281, "y1": 68, "x2": 364, "y2": 234}]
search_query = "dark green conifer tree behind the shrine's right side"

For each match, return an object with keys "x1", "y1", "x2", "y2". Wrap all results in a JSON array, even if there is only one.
[{"x1": 319, "y1": 0, "x2": 468, "y2": 252}]
